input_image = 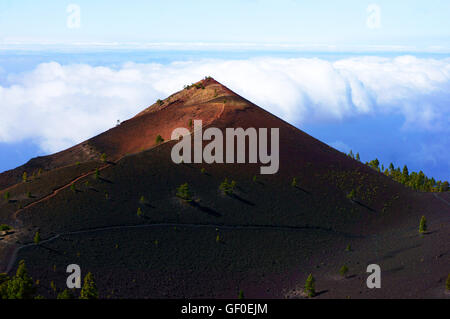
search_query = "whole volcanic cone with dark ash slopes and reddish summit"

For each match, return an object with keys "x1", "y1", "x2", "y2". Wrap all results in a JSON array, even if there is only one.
[{"x1": 0, "y1": 79, "x2": 450, "y2": 298}]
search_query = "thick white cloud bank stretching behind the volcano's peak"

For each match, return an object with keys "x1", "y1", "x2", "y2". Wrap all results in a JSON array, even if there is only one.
[{"x1": 0, "y1": 56, "x2": 450, "y2": 152}]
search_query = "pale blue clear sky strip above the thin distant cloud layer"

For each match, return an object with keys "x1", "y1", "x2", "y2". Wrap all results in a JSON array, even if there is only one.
[{"x1": 0, "y1": 0, "x2": 450, "y2": 50}]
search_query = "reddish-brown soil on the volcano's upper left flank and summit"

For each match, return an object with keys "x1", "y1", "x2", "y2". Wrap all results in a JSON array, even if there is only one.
[{"x1": 0, "y1": 79, "x2": 225, "y2": 190}]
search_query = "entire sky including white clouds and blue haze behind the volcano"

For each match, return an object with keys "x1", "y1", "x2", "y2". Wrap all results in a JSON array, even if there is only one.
[{"x1": 0, "y1": 0, "x2": 450, "y2": 179}]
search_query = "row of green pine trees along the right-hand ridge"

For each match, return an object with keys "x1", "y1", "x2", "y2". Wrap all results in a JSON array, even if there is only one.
[{"x1": 348, "y1": 151, "x2": 450, "y2": 192}]
